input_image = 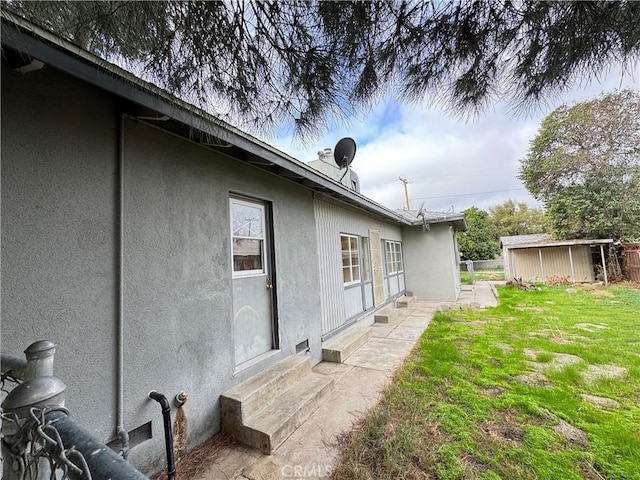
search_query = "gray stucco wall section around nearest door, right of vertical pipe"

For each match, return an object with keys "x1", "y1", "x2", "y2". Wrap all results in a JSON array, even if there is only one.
[{"x1": 124, "y1": 122, "x2": 321, "y2": 468}]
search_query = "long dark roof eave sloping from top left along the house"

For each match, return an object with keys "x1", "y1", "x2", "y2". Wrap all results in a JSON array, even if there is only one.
[{"x1": 0, "y1": 10, "x2": 411, "y2": 225}]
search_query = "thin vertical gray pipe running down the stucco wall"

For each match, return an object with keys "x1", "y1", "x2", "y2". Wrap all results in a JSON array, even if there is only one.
[{"x1": 116, "y1": 114, "x2": 129, "y2": 458}]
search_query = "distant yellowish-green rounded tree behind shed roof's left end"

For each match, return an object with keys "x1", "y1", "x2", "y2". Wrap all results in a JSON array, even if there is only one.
[{"x1": 489, "y1": 200, "x2": 547, "y2": 240}]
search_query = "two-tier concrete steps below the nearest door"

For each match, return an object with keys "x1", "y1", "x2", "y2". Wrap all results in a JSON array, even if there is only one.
[{"x1": 220, "y1": 355, "x2": 334, "y2": 454}]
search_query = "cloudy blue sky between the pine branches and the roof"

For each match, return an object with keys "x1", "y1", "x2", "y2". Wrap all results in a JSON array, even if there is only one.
[{"x1": 269, "y1": 65, "x2": 640, "y2": 212}]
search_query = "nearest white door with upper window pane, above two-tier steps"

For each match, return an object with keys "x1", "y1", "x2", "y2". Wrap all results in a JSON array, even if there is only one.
[{"x1": 230, "y1": 198, "x2": 276, "y2": 367}]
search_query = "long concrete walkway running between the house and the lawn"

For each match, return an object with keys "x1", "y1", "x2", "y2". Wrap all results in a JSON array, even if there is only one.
[{"x1": 194, "y1": 282, "x2": 497, "y2": 480}]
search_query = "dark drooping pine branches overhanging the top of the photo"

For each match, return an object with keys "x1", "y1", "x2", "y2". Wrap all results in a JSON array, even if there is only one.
[{"x1": 5, "y1": 0, "x2": 640, "y2": 134}]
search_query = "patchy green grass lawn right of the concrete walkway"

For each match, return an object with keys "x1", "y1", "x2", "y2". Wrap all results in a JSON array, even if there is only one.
[{"x1": 333, "y1": 287, "x2": 640, "y2": 480}]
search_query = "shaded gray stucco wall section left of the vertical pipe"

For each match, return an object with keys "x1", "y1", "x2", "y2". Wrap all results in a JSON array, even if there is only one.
[{"x1": 1, "y1": 67, "x2": 118, "y2": 439}]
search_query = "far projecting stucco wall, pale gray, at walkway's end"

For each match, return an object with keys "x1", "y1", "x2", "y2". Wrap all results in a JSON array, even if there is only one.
[{"x1": 402, "y1": 223, "x2": 460, "y2": 302}]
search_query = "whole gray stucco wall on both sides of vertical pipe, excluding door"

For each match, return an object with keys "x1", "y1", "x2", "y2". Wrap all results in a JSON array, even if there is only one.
[{"x1": 2, "y1": 62, "x2": 321, "y2": 471}]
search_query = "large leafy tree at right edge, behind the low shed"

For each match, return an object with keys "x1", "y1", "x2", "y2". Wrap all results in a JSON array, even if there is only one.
[{"x1": 519, "y1": 90, "x2": 640, "y2": 240}]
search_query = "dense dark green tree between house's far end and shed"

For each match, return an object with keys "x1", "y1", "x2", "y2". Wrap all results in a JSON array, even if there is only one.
[{"x1": 457, "y1": 207, "x2": 500, "y2": 260}]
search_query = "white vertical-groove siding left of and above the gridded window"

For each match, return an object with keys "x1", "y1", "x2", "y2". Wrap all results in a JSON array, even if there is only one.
[{"x1": 314, "y1": 198, "x2": 402, "y2": 335}]
